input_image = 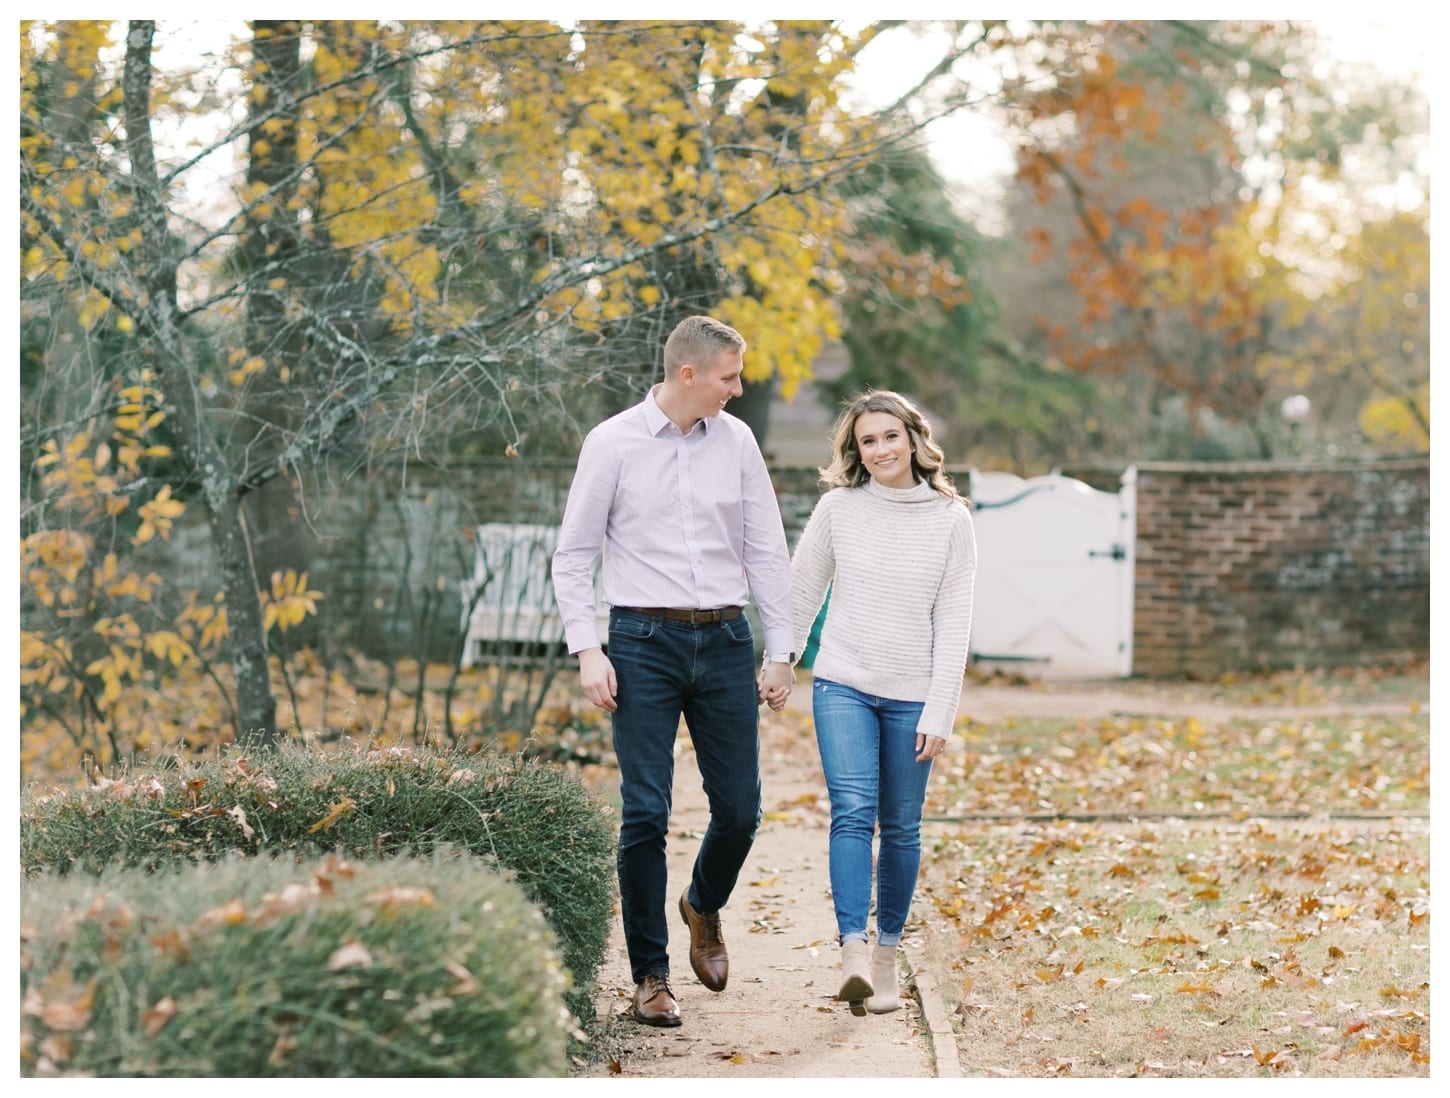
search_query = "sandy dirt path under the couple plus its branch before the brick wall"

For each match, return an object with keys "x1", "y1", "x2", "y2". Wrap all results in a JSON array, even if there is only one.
[{"x1": 576, "y1": 676, "x2": 1428, "y2": 1079}]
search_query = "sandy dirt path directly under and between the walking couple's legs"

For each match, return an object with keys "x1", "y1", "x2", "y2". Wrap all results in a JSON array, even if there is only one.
[{"x1": 586, "y1": 715, "x2": 937, "y2": 1079}]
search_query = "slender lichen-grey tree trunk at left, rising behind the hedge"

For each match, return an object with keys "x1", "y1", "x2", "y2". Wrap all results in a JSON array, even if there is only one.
[{"x1": 123, "y1": 20, "x2": 277, "y2": 747}]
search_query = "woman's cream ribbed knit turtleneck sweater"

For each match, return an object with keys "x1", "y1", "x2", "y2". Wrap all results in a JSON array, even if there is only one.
[{"x1": 790, "y1": 480, "x2": 977, "y2": 738}]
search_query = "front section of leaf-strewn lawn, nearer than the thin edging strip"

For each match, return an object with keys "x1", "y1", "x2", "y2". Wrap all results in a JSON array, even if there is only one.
[{"x1": 916, "y1": 821, "x2": 1430, "y2": 1078}]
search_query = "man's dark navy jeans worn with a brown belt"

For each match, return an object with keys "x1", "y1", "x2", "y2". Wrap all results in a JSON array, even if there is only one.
[{"x1": 609, "y1": 608, "x2": 760, "y2": 983}]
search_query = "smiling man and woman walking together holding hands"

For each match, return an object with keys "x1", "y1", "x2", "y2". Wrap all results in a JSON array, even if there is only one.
[{"x1": 552, "y1": 316, "x2": 976, "y2": 1025}]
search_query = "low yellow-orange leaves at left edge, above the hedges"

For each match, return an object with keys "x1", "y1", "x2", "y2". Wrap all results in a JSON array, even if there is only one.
[{"x1": 19, "y1": 371, "x2": 322, "y2": 773}]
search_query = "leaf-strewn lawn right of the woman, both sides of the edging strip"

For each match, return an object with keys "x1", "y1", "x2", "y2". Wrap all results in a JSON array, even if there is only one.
[{"x1": 908, "y1": 673, "x2": 1430, "y2": 1079}]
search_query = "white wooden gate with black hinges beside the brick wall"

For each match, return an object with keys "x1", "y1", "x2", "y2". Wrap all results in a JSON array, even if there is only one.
[{"x1": 969, "y1": 467, "x2": 1138, "y2": 679}]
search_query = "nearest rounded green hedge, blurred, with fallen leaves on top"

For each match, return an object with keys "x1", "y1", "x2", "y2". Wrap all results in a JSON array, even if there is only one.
[{"x1": 20, "y1": 854, "x2": 573, "y2": 1078}]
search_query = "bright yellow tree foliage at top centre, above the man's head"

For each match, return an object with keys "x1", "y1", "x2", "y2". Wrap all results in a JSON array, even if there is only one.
[{"x1": 269, "y1": 20, "x2": 873, "y2": 396}]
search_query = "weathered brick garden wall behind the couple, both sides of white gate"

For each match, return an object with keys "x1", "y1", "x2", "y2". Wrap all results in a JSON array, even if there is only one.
[{"x1": 150, "y1": 460, "x2": 1430, "y2": 677}]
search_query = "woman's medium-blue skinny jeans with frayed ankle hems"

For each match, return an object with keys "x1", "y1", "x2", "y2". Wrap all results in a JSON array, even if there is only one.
[{"x1": 812, "y1": 679, "x2": 931, "y2": 946}]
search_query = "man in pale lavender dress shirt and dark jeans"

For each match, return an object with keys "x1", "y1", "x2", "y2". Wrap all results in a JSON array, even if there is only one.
[{"x1": 552, "y1": 316, "x2": 793, "y2": 1025}]
